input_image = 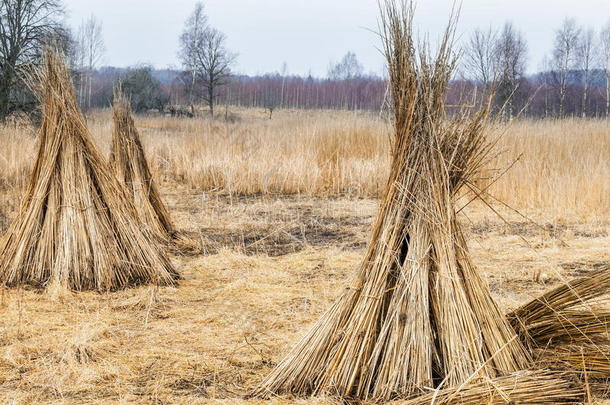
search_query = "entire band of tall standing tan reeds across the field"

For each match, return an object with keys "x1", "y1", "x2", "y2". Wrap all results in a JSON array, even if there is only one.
[{"x1": 0, "y1": 109, "x2": 610, "y2": 218}]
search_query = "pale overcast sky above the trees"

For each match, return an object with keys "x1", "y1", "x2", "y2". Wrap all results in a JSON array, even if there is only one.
[{"x1": 64, "y1": 0, "x2": 610, "y2": 76}]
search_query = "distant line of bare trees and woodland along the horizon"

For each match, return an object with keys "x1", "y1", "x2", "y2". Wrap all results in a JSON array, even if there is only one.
[{"x1": 0, "y1": 0, "x2": 610, "y2": 120}]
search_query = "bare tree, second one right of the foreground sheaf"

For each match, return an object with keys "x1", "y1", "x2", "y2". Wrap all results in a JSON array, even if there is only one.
[{"x1": 494, "y1": 23, "x2": 527, "y2": 119}]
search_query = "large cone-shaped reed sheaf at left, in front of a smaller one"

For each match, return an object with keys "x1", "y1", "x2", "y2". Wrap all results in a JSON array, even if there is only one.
[{"x1": 0, "y1": 49, "x2": 178, "y2": 290}]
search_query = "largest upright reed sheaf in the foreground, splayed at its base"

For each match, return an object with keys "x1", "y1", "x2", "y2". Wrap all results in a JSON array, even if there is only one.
[{"x1": 255, "y1": 0, "x2": 604, "y2": 404}]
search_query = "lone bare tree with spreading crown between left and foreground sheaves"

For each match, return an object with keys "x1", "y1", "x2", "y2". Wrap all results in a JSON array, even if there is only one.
[{"x1": 180, "y1": 3, "x2": 236, "y2": 116}]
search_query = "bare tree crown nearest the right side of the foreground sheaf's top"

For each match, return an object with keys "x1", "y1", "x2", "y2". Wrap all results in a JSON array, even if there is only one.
[{"x1": 463, "y1": 27, "x2": 498, "y2": 90}]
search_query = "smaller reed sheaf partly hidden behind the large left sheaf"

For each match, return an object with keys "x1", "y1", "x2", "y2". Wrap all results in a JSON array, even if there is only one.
[{"x1": 110, "y1": 86, "x2": 201, "y2": 253}]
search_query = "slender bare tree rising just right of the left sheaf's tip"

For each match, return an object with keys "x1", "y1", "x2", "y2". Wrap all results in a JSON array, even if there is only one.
[{"x1": 76, "y1": 15, "x2": 106, "y2": 110}]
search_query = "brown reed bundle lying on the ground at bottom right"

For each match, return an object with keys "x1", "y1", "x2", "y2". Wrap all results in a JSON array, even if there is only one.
[{"x1": 508, "y1": 266, "x2": 610, "y2": 395}]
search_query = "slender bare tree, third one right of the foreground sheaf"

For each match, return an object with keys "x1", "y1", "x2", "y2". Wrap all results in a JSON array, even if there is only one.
[{"x1": 553, "y1": 18, "x2": 580, "y2": 117}]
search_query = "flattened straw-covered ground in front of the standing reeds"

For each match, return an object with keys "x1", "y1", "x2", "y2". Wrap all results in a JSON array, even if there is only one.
[{"x1": 0, "y1": 193, "x2": 610, "y2": 405}]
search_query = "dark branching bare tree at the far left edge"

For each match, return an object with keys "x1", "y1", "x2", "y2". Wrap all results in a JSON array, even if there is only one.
[{"x1": 0, "y1": 0, "x2": 66, "y2": 119}]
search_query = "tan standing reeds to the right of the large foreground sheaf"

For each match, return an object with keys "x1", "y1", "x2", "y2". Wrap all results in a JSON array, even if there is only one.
[{"x1": 491, "y1": 119, "x2": 610, "y2": 216}]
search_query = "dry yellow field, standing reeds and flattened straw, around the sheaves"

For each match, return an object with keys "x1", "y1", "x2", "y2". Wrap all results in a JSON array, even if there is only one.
[{"x1": 0, "y1": 110, "x2": 610, "y2": 404}]
